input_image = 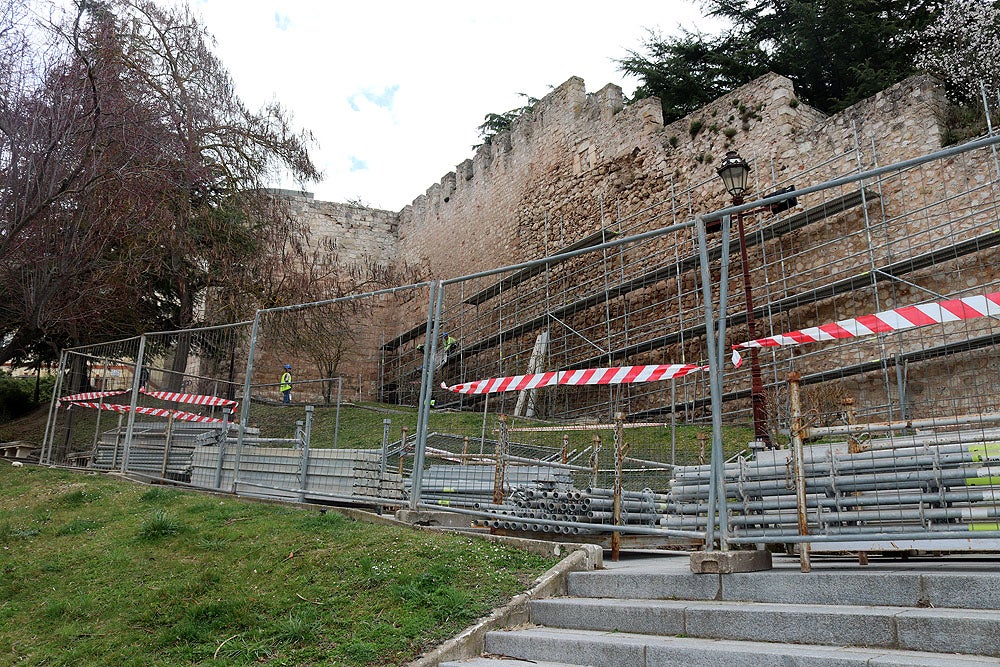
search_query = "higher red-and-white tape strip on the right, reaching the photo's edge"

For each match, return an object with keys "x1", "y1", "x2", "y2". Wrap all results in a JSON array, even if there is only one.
[{"x1": 733, "y1": 292, "x2": 1000, "y2": 367}]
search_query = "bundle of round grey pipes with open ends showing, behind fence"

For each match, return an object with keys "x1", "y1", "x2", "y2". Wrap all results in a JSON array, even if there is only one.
[{"x1": 475, "y1": 487, "x2": 667, "y2": 535}]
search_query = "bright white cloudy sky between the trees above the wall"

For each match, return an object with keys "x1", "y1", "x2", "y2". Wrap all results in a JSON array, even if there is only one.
[{"x1": 191, "y1": 0, "x2": 715, "y2": 211}]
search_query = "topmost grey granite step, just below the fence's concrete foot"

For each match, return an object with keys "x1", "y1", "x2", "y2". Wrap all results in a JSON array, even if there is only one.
[{"x1": 568, "y1": 562, "x2": 1000, "y2": 609}]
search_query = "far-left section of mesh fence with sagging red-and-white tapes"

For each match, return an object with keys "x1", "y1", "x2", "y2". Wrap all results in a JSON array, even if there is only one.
[{"x1": 40, "y1": 322, "x2": 250, "y2": 472}]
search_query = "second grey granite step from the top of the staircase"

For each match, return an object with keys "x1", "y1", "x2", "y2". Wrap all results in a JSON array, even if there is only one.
[{"x1": 531, "y1": 598, "x2": 1000, "y2": 656}]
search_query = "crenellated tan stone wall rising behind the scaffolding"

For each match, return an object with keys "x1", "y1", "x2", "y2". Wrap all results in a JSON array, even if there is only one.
[{"x1": 288, "y1": 74, "x2": 997, "y2": 420}]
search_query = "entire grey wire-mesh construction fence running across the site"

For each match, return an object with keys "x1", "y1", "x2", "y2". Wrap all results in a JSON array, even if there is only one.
[{"x1": 44, "y1": 122, "x2": 1000, "y2": 550}]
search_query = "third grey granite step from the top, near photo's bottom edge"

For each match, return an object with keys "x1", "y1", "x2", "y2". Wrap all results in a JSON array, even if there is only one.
[{"x1": 484, "y1": 628, "x2": 1000, "y2": 667}]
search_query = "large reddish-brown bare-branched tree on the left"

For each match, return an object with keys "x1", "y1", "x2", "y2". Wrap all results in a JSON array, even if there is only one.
[{"x1": 0, "y1": 0, "x2": 318, "y2": 378}]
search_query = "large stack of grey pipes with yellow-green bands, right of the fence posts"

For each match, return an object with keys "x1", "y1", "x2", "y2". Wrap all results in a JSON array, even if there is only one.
[{"x1": 662, "y1": 430, "x2": 1000, "y2": 541}]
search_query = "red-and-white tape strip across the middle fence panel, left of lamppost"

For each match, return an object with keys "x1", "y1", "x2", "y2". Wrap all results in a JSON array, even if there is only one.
[{"x1": 441, "y1": 364, "x2": 708, "y2": 394}]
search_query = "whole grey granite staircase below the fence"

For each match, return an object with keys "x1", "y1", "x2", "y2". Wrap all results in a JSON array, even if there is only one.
[{"x1": 441, "y1": 556, "x2": 1000, "y2": 667}]
